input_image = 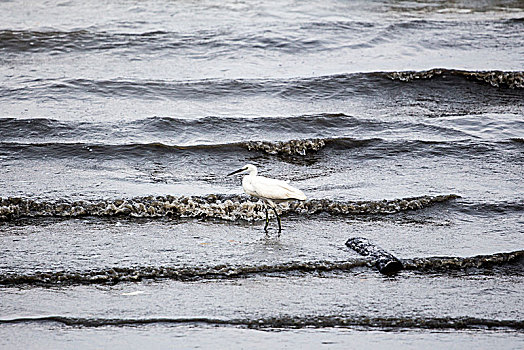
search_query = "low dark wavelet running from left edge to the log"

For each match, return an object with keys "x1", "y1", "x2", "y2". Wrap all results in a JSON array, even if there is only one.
[{"x1": 0, "y1": 258, "x2": 369, "y2": 287}]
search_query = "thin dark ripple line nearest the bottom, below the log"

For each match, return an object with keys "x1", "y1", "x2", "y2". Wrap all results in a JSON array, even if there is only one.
[{"x1": 0, "y1": 315, "x2": 524, "y2": 331}]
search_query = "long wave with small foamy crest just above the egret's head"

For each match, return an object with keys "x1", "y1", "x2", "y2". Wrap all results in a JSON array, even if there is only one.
[{"x1": 0, "y1": 137, "x2": 519, "y2": 162}]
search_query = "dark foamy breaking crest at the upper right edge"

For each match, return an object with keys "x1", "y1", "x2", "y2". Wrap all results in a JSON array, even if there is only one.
[{"x1": 385, "y1": 68, "x2": 524, "y2": 89}]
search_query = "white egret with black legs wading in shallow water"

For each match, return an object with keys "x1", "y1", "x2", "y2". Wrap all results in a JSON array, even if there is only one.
[{"x1": 227, "y1": 164, "x2": 307, "y2": 236}]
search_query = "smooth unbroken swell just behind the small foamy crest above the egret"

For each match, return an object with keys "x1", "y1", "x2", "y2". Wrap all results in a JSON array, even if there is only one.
[{"x1": 0, "y1": 113, "x2": 358, "y2": 142}]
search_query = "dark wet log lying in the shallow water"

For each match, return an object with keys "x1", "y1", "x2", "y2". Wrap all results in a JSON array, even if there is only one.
[{"x1": 346, "y1": 237, "x2": 403, "y2": 274}]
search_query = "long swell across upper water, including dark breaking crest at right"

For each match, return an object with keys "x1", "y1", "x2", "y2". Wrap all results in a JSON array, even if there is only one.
[{"x1": 5, "y1": 69, "x2": 524, "y2": 100}]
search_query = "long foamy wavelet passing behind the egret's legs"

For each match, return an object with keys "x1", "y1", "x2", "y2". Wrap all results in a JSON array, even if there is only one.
[{"x1": 0, "y1": 194, "x2": 458, "y2": 221}]
